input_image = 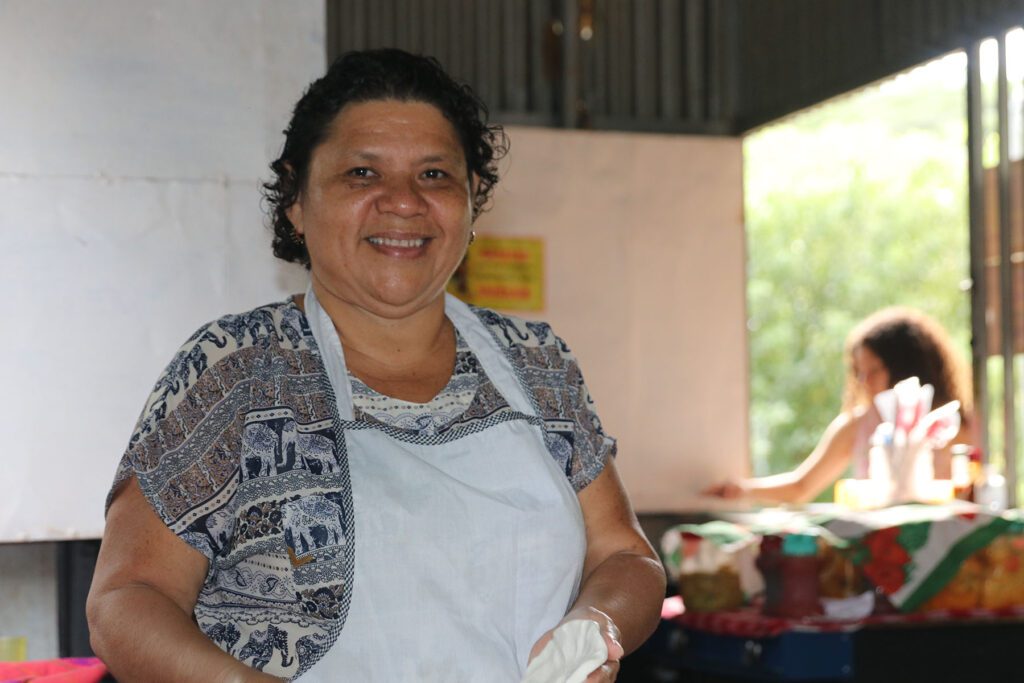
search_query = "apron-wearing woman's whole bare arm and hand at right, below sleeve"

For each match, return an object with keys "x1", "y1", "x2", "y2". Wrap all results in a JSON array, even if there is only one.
[{"x1": 530, "y1": 458, "x2": 665, "y2": 682}]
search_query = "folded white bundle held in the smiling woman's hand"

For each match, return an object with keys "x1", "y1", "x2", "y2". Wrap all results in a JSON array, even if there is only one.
[{"x1": 522, "y1": 620, "x2": 608, "y2": 683}]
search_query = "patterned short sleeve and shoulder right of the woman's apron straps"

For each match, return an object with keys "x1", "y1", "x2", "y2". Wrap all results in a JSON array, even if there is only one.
[{"x1": 476, "y1": 308, "x2": 616, "y2": 493}]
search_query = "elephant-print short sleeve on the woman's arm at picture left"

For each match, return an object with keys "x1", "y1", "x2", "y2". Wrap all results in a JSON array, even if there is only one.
[{"x1": 106, "y1": 323, "x2": 249, "y2": 561}]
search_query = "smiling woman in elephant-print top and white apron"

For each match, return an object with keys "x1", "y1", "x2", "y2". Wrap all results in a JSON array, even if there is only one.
[{"x1": 88, "y1": 50, "x2": 665, "y2": 682}]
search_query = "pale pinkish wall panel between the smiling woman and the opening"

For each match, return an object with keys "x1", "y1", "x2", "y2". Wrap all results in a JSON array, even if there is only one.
[{"x1": 477, "y1": 127, "x2": 749, "y2": 512}]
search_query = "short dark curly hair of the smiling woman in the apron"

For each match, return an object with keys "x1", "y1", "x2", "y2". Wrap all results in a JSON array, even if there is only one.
[{"x1": 263, "y1": 48, "x2": 508, "y2": 268}]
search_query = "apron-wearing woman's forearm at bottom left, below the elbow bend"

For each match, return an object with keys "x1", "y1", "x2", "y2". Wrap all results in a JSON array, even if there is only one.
[{"x1": 87, "y1": 584, "x2": 282, "y2": 683}]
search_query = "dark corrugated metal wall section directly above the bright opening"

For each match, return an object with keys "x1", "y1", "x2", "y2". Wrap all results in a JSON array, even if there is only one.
[{"x1": 732, "y1": 0, "x2": 1024, "y2": 132}]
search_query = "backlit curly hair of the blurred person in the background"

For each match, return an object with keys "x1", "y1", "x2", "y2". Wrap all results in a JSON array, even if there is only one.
[{"x1": 845, "y1": 306, "x2": 972, "y2": 417}]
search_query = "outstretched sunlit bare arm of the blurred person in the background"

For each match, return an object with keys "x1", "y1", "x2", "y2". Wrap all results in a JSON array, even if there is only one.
[{"x1": 702, "y1": 413, "x2": 863, "y2": 503}]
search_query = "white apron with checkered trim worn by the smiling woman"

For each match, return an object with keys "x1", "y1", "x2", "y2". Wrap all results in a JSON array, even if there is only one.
[{"x1": 300, "y1": 287, "x2": 586, "y2": 683}]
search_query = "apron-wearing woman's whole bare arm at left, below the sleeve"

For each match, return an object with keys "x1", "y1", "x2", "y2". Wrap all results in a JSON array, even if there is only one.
[{"x1": 86, "y1": 478, "x2": 281, "y2": 683}]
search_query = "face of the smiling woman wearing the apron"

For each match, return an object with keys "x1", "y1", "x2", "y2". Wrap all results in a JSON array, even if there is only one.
[{"x1": 288, "y1": 99, "x2": 472, "y2": 318}]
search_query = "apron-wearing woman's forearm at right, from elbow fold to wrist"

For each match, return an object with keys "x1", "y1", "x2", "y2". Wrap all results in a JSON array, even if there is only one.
[{"x1": 572, "y1": 551, "x2": 665, "y2": 653}]
